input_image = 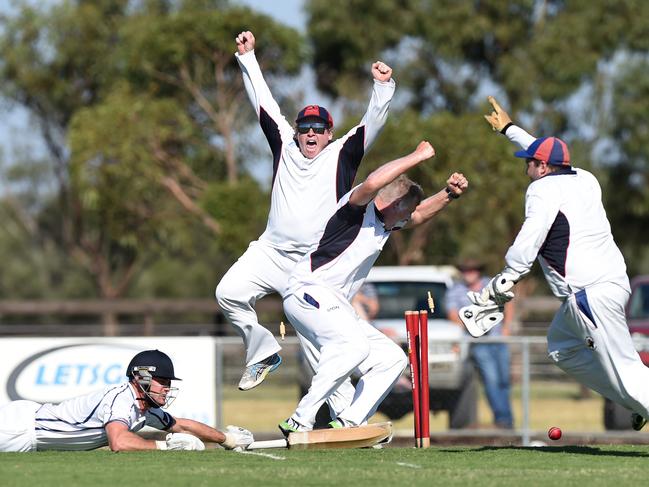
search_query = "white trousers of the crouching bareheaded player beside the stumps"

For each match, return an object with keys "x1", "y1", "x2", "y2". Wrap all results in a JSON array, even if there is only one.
[{"x1": 284, "y1": 286, "x2": 407, "y2": 428}]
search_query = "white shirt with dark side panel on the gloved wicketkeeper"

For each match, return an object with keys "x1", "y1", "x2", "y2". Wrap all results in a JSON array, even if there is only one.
[{"x1": 505, "y1": 126, "x2": 630, "y2": 298}]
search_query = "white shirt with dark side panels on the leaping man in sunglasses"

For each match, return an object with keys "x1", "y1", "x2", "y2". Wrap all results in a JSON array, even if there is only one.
[{"x1": 236, "y1": 51, "x2": 395, "y2": 253}]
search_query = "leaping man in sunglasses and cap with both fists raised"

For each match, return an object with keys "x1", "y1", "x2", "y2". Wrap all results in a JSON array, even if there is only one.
[{"x1": 216, "y1": 31, "x2": 395, "y2": 409}]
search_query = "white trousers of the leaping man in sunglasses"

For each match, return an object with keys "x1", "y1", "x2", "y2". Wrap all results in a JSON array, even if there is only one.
[{"x1": 216, "y1": 240, "x2": 354, "y2": 416}]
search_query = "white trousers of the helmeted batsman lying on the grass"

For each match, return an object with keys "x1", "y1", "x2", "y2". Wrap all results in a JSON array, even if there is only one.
[{"x1": 0, "y1": 401, "x2": 41, "y2": 452}]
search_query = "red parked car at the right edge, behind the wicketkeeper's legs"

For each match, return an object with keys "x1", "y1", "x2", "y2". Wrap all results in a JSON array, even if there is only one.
[{"x1": 604, "y1": 275, "x2": 649, "y2": 430}]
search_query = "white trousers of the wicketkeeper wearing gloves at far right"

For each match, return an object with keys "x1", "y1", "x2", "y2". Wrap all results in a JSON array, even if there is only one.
[{"x1": 548, "y1": 283, "x2": 649, "y2": 421}]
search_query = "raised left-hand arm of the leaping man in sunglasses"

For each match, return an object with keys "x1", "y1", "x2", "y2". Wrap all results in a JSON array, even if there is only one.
[{"x1": 235, "y1": 31, "x2": 294, "y2": 147}]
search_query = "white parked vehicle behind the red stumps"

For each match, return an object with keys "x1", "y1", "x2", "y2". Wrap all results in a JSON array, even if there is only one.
[{"x1": 301, "y1": 266, "x2": 478, "y2": 428}]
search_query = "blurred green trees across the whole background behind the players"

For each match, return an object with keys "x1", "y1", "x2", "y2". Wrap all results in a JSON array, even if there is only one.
[{"x1": 0, "y1": 0, "x2": 649, "y2": 304}]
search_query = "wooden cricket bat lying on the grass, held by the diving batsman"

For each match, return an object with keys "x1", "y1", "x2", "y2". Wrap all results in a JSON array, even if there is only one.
[{"x1": 246, "y1": 421, "x2": 392, "y2": 450}]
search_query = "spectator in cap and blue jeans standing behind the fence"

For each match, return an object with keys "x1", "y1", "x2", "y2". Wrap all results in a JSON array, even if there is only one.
[{"x1": 446, "y1": 259, "x2": 513, "y2": 429}]
